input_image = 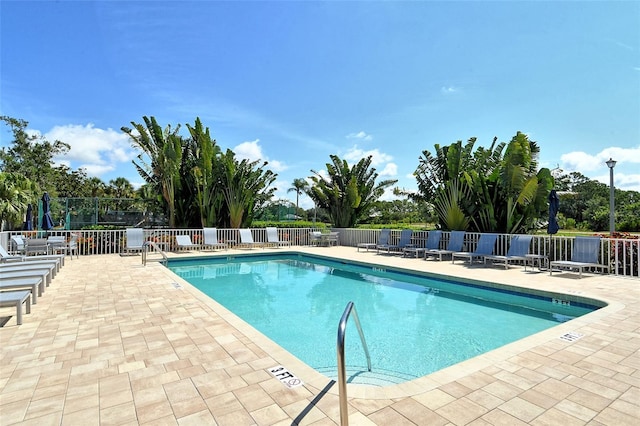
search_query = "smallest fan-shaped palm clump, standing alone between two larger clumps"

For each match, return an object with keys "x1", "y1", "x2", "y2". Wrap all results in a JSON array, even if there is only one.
[{"x1": 307, "y1": 155, "x2": 397, "y2": 228}]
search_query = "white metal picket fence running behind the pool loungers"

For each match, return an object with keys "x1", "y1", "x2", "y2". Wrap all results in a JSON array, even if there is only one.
[{"x1": 0, "y1": 228, "x2": 640, "y2": 278}]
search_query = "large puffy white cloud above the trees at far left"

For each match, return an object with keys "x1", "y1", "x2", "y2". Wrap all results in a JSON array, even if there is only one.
[{"x1": 44, "y1": 123, "x2": 136, "y2": 177}]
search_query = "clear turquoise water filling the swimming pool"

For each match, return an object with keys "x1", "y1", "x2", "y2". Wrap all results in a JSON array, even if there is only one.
[{"x1": 169, "y1": 254, "x2": 598, "y2": 385}]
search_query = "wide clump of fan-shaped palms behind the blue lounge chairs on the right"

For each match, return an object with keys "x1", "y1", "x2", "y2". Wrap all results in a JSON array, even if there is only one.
[{"x1": 407, "y1": 132, "x2": 553, "y2": 233}]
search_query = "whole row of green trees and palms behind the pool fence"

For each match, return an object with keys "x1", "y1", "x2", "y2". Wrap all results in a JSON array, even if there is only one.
[{"x1": 0, "y1": 117, "x2": 640, "y2": 233}]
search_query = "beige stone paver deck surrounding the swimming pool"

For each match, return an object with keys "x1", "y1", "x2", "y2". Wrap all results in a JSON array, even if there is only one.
[{"x1": 0, "y1": 247, "x2": 640, "y2": 426}]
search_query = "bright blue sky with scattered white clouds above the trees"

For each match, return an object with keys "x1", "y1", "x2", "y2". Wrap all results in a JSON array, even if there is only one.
[{"x1": 0, "y1": 0, "x2": 640, "y2": 207}]
